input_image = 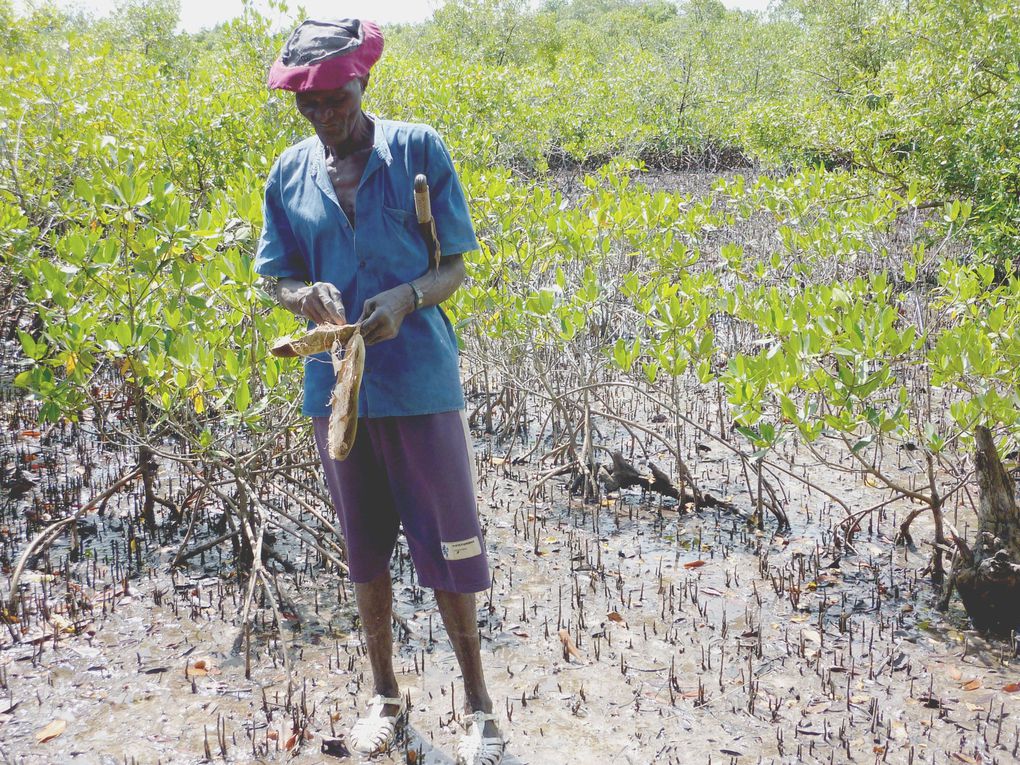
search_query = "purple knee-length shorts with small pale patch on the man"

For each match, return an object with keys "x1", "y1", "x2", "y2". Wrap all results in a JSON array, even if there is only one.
[{"x1": 312, "y1": 411, "x2": 491, "y2": 593}]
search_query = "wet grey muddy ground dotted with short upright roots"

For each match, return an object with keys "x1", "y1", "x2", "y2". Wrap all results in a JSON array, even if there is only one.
[{"x1": 0, "y1": 385, "x2": 1020, "y2": 764}]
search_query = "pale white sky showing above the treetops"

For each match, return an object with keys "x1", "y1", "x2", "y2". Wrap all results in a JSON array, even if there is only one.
[{"x1": 39, "y1": 0, "x2": 768, "y2": 32}]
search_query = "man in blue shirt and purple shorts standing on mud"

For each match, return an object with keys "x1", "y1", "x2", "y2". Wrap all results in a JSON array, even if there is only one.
[{"x1": 255, "y1": 19, "x2": 504, "y2": 765}]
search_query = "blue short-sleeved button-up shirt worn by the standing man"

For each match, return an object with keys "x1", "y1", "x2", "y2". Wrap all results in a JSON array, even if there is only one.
[{"x1": 255, "y1": 117, "x2": 478, "y2": 417}]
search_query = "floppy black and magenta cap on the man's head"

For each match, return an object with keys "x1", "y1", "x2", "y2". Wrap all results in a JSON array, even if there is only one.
[{"x1": 267, "y1": 18, "x2": 383, "y2": 93}]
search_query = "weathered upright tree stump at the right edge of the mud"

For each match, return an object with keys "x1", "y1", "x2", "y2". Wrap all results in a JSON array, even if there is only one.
[{"x1": 939, "y1": 425, "x2": 1020, "y2": 634}]
